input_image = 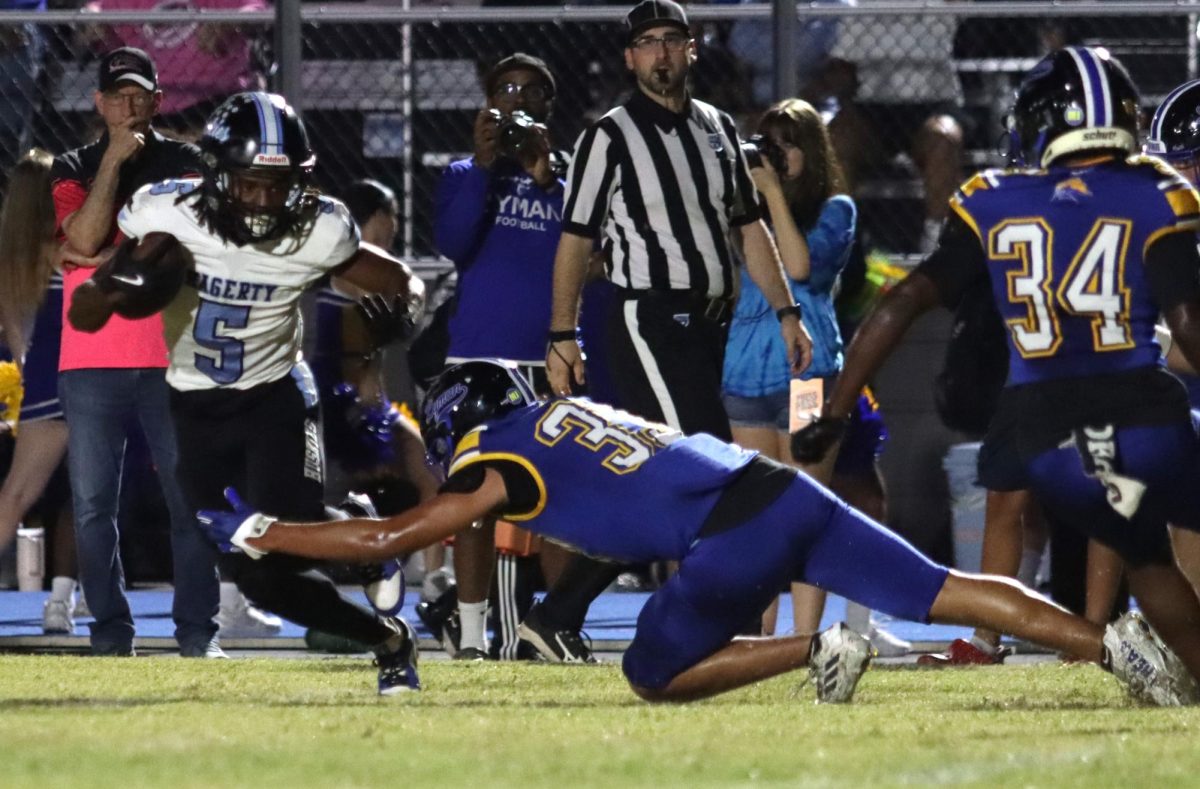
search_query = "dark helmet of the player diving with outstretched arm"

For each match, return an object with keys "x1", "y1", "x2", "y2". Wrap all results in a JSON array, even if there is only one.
[{"x1": 421, "y1": 360, "x2": 538, "y2": 472}]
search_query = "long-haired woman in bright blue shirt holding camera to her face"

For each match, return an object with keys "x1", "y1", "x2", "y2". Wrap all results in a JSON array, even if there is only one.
[{"x1": 724, "y1": 98, "x2": 906, "y2": 654}]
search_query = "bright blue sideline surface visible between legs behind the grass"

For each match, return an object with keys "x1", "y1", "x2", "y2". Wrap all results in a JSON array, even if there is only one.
[{"x1": 0, "y1": 588, "x2": 993, "y2": 652}]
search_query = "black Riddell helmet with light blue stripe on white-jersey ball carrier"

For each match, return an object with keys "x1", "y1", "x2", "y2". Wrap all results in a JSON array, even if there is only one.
[{"x1": 198, "y1": 92, "x2": 317, "y2": 246}]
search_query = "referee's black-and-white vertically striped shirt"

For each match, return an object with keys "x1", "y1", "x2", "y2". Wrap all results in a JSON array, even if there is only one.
[{"x1": 563, "y1": 91, "x2": 761, "y2": 297}]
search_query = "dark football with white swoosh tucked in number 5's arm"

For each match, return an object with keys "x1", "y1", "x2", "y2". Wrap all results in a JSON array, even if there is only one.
[{"x1": 67, "y1": 233, "x2": 193, "y2": 332}]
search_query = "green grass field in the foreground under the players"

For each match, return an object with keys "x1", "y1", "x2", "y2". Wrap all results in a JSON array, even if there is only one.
[{"x1": 0, "y1": 656, "x2": 1200, "y2": 789}]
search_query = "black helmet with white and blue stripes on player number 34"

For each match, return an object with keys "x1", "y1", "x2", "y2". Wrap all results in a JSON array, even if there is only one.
[{"x1": 1008, "y1": 47, "x2": 1138, "y2": 167}]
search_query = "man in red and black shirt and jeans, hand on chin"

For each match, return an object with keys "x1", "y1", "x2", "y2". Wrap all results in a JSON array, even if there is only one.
[{"x1": 50, "y1": 47, "x2": 224, "y2": 657}]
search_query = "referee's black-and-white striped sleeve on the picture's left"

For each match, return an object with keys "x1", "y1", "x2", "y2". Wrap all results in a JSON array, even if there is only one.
[{"x1": 563, "y1": 120, "x2": 618, "y2": 239}]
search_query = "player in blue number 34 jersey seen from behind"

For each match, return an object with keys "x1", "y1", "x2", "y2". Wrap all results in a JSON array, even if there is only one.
[{"x1": 793, "y1": 47, "x2": 1200, "y2": 695}]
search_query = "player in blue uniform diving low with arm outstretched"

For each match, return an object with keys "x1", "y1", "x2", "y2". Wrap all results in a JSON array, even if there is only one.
[{"x1": 200, "y1": 361, "x2": 1180, "y2": 704}]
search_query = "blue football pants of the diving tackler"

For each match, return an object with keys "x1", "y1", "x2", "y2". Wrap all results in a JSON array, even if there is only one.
[{"x1": 624, "y1": 475, "x2": 949, "y2": 689}]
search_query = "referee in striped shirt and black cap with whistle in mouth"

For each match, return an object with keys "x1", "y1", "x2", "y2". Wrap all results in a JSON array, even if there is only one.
[{"x1": 518, "y1": 0, "x2": 812, "y2": 662}]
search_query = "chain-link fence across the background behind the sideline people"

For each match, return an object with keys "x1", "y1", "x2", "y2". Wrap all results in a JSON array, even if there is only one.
[{"x1": 0, "y1": 0, "x2": 1200, "y2": 261}]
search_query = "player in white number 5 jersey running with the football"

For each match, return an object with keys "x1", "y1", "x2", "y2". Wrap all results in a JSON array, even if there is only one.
[{"x1": 68, "y1": 92, "x2": 424, "y2": 694}]
